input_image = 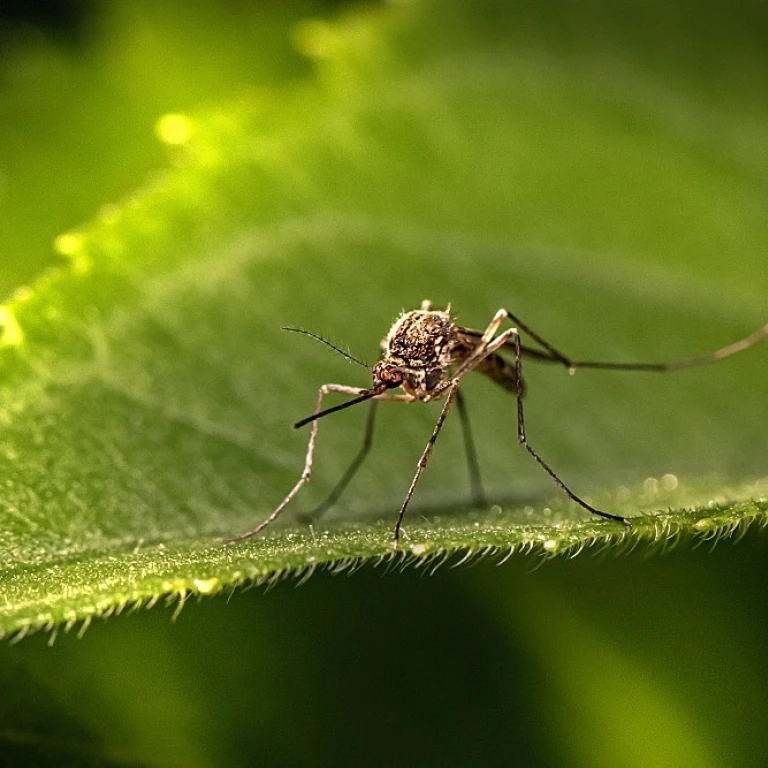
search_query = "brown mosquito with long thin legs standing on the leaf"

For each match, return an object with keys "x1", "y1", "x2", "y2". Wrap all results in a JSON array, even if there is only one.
[{"x1": 228, "y1": 301, "x2": 768, "y2": 549}]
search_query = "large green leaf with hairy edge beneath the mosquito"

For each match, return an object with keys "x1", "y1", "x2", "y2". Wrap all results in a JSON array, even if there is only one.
[{"x1": 0, "y1": 0, "x2": 768, "y2": 633}]
